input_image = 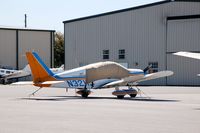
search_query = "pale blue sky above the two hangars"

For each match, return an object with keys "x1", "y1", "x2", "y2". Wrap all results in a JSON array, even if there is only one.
[{"x1": 0, "y1": 0, "x2": 162, "y2": 32}]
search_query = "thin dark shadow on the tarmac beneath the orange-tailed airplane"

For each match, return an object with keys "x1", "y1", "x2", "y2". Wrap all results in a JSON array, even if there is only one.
[{"x1": 19, "y1": 96, "x2": 179, "y2": 102}]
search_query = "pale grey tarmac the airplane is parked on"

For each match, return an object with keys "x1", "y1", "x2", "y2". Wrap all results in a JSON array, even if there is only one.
[{"x1": 0, "y1": 85, "x2": 200, "y2": 133}]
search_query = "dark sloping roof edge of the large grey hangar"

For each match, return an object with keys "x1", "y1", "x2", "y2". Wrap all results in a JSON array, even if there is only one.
[{"x1": 63, "y1": 0, "x2": 200, "y2": 24}]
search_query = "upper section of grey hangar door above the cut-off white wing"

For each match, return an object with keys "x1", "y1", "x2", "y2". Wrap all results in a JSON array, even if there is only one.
[{"x1": 167, "y1": 18, "x2": 200, "y2": 52}]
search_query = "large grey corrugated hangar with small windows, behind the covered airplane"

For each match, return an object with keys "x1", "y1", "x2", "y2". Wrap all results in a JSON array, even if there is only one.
[{"x1": 63, "y1": 0, "x2": 200, "y2": 85}]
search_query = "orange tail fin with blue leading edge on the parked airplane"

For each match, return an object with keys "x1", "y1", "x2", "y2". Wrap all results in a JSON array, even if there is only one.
[{"x1": 26, "y1": 52, "x2": 56, "y2": 83}]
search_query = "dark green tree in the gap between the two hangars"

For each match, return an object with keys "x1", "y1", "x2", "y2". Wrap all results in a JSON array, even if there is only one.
[{"x1": 54, "y1": 32, "x2": 64, "y2": 67}]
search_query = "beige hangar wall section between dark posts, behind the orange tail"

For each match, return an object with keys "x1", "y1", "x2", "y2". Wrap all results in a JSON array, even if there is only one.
[{"x1": 18, "y1": 31, "x2": 51, "y2": 69}]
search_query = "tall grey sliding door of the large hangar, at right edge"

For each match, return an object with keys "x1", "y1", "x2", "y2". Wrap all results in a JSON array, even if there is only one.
[{"x1": 167, "y1": 18, "x2": 200, "y2": 85}]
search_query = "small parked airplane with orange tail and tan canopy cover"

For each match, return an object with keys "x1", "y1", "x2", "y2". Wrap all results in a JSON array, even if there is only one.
[{"x1": 14, "y1": 52, "x2": 173, "y2": 99}]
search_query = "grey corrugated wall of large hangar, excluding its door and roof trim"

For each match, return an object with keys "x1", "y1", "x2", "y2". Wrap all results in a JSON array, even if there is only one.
[{"x1": 65, "y1": 2, "x2": 200, "y2": 85}]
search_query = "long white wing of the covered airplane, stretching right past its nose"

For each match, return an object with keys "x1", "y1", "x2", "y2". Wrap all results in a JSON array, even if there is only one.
[{"x1": 102, "y1": 71, "x2": 173, "y2": 88}]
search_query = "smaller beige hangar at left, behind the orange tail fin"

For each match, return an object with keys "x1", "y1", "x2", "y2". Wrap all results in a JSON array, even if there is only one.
[{"x1": 0, "y1": 27, "x2": 55, "y2": 69}]
